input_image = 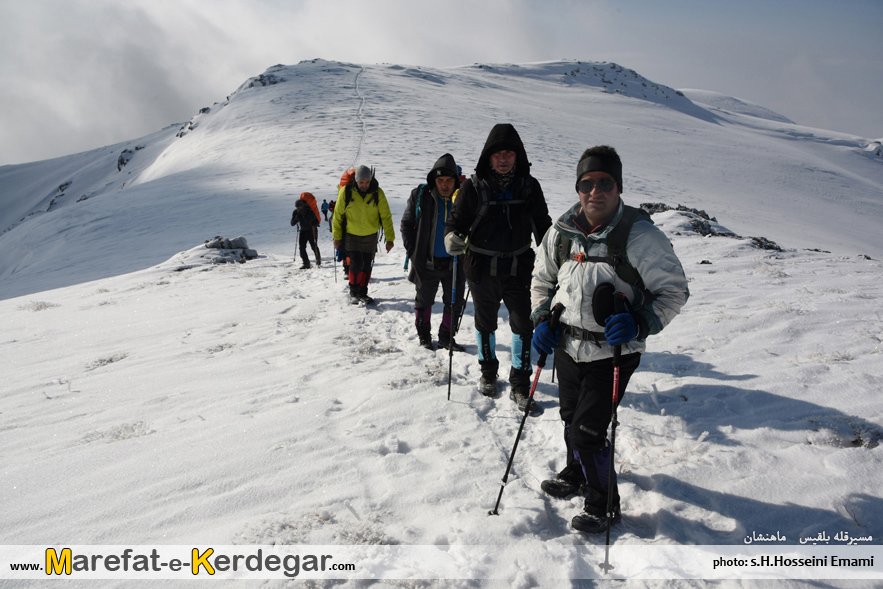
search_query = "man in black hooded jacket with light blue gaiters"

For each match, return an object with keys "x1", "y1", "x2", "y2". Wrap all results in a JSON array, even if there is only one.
[{"x1": 445, "y1": 124, "x2": 552, "y2": 410}]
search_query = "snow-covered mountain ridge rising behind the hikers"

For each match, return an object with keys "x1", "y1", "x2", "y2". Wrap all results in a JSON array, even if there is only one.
[{"x1": 0, "y1": 59, "x2": 883, "y2": 296}]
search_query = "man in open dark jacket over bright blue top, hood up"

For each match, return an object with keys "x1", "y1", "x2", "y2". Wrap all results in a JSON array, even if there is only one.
[{"x1": 401, "y1": 153, "x2": 466, "y2": 352}]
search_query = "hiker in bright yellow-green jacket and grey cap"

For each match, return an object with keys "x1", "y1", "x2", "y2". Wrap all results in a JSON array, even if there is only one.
[{"x1": 332, "y1": 166, "x2": 395, "y2": 305}]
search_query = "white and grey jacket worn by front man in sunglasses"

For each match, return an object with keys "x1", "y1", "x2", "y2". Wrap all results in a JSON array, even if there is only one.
[{"x1": 530, "y1": 200, "x2": 690, "y2": 362}]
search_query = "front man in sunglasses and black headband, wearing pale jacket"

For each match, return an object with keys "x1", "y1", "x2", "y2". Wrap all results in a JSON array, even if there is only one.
[{"x1": 531, "y1": 145, "x2": 689, "y2": 533}]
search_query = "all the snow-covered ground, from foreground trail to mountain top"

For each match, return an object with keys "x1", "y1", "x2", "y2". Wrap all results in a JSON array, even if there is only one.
[{"x1": 0, "y1": 61, "x2": 883, "y2": 587}]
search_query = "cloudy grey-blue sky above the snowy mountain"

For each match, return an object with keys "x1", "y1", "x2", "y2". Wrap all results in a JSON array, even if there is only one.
[{"x1": 0, "y1": 0, "x2": 883, "y2": 165}]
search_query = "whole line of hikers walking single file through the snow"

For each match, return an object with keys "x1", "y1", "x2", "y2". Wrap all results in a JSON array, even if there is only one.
[{"x1": 292, "y1": 124, "x2": 689, "y2": 533}]
